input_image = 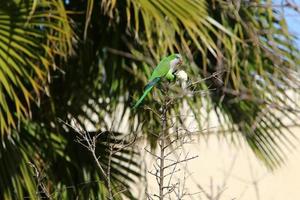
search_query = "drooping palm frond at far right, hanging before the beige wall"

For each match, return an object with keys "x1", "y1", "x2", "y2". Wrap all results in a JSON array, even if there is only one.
[{"x1": 195, "y1": 2, "x2": 300, "y2": 169}]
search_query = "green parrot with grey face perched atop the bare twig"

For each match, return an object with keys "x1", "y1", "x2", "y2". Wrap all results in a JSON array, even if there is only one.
[{"x1": 133, "y1": 54, "x2": 183, "y2": 109}]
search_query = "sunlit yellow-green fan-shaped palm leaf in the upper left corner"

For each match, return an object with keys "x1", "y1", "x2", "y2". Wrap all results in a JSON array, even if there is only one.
[{"x1": 0, "y1": 0, "x2": 73, "y2": 134}]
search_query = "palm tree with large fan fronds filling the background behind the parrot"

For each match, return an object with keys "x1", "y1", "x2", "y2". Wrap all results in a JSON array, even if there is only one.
[{"x1": 0, "y1": 0, "x2": 300, "y2": 199}]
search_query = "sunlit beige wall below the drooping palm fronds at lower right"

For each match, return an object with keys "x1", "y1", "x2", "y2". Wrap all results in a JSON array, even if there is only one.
[{"x1": 138, "y1": 129, "x2": 300, "y2": 200}]
